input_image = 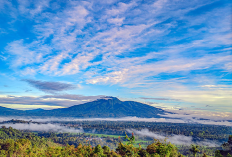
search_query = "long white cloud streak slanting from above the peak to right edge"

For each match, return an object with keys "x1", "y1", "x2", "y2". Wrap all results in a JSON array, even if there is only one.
[{"x1": 88, "y1": 54, "x2": 232, "y2": 85}]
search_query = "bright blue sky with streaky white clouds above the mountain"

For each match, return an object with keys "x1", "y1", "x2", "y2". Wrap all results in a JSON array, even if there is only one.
[{"x1": 0, "y1": 0, "x2": 232, "y2": 116}]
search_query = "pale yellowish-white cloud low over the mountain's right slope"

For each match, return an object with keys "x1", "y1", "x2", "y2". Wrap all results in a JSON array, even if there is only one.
[{"x1": 129, "y1": 82, "x2": 232, "y2": 112}]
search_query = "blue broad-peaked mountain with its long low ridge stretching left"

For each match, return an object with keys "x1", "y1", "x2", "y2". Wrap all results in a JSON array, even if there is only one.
[{"x1": 0, "y1": 97, "x2": 170, "y2": 118}]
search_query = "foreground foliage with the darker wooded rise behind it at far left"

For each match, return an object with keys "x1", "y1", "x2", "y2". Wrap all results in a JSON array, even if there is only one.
[{"x1": 0, "y1": 127, "x2": 181, "y2": 157}]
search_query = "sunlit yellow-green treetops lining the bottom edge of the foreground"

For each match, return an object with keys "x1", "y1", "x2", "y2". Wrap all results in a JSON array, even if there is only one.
[{"x1": 0, "y1": 139, "x2": 178, "y2": 157}]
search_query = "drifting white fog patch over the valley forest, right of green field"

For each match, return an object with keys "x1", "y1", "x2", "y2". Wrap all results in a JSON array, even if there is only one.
[{"x1": 126, "y1": 129, "x2": 220, "y2": 147}]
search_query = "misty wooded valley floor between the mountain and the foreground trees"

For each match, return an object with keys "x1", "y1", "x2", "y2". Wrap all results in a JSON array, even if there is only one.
[{"x1": 0, "y1": 119, "x2": 232, "y2": 156}]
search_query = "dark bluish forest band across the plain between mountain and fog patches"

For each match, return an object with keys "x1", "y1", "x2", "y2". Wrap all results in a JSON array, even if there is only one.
[{"x1": 0, "y1": 119, "x2": 232, "y2": 143}]
